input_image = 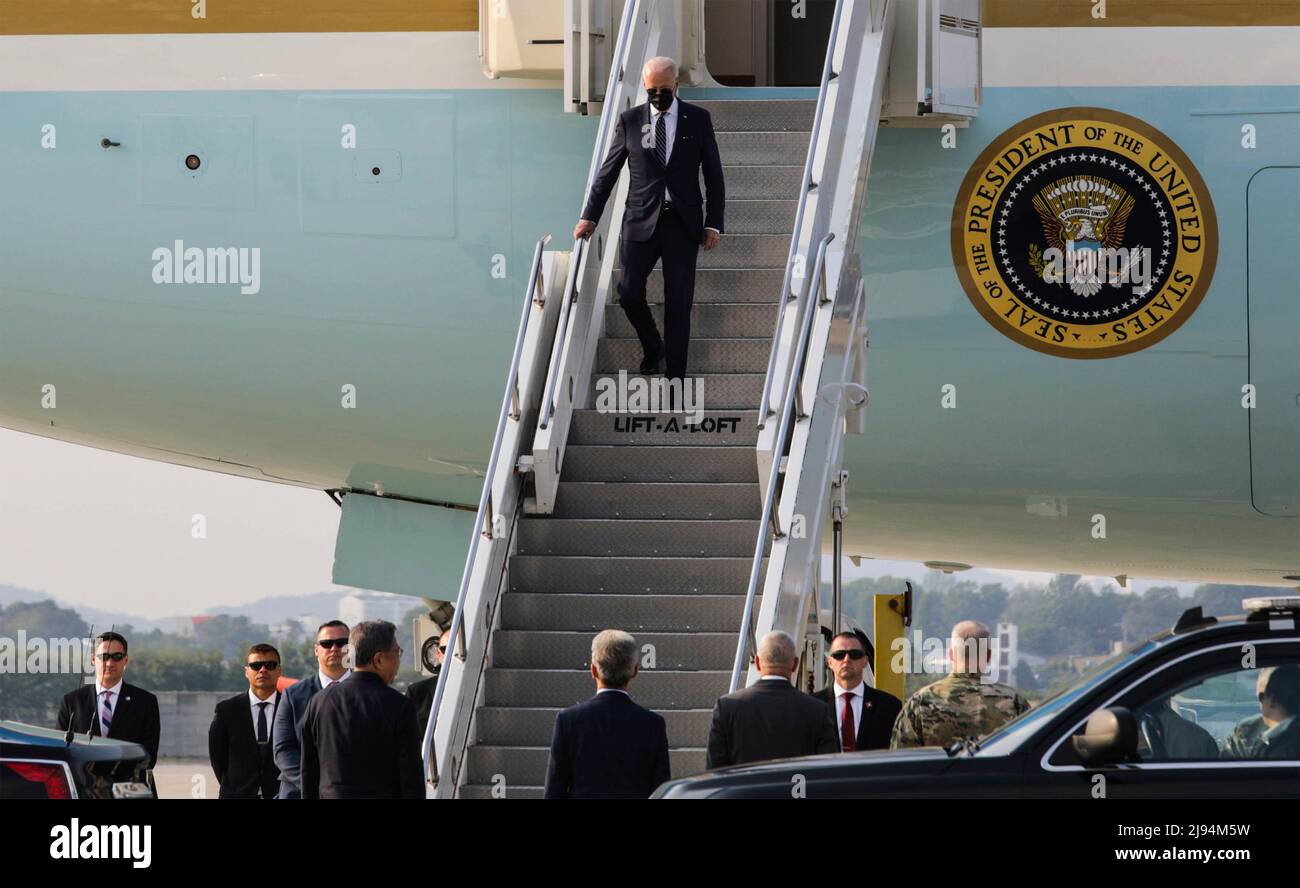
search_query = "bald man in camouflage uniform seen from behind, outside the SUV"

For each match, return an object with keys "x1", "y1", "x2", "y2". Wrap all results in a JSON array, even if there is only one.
[{"x1": 889, "y1": 620, "x2": 1030, "y2": 749}]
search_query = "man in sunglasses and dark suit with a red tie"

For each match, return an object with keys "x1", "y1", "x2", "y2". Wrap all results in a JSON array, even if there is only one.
[{"x1": 813, "y1": 632, "x2": 902, "y2": 753}]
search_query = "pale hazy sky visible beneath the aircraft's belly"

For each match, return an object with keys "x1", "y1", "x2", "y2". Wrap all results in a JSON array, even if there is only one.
[{"x1": 0, "y1": 429, "x2": 1190, "y2": 619}]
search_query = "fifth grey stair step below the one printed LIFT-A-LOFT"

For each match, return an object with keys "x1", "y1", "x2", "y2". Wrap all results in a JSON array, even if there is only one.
[{"x1": 501, "y1": 598, "x2": 745, "y2": 631}]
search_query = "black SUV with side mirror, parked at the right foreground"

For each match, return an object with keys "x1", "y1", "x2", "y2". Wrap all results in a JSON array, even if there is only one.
[{"x1": 654, "y1": 597, "x2": 1300, "y2": 798}]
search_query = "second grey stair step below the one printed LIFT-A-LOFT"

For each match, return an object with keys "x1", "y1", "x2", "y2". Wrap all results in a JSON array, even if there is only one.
[{"x1": 553, "y1": 481, "x2": 762, "y2": 519}]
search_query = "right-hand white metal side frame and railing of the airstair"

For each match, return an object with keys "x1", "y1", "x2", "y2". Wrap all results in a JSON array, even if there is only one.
[{"x1": 732, "y1": 0, "x2": 897, "y2": 690}]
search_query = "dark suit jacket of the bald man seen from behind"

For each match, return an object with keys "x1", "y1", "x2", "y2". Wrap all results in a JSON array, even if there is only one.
[{"x1": 705, "y1": 680, "x2": 840, "y2": 770}]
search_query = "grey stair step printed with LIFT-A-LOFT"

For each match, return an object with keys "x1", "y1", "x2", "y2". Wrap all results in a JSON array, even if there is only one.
[{"x1": 569, "y1": 413, "x2": 758, "y2": 447}]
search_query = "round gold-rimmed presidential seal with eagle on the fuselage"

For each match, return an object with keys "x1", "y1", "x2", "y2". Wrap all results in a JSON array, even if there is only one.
[{"x1": 952, "y1": 108, "x2": 1218, "y2": 358}]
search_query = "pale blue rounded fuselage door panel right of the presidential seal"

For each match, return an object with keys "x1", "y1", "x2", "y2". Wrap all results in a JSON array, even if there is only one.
[{"x1": 1245, "y1": 166, "x2": 1300, "y2": 517}]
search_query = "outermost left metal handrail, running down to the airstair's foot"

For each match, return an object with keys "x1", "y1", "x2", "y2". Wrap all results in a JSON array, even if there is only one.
[{"x1": 424, "y1": 234, "x2": 551, "y2": 785}]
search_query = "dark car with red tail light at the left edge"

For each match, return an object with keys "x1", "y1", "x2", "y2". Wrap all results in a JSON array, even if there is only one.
[{"x1": 0, "y1": 722, "x2": 153, "y2": 800}]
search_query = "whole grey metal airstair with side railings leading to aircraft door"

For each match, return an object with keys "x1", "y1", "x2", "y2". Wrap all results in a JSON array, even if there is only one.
[{"x1": 424, "y1": 0, "x2": 977, "y2": 798}]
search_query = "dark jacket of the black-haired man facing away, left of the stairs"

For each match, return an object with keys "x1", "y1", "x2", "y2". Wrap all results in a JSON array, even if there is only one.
[{"x1": 302, "y1": 672, "x2": 424, "y2": 798}]
